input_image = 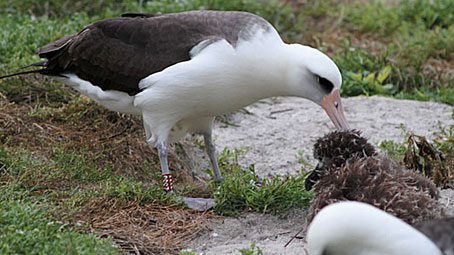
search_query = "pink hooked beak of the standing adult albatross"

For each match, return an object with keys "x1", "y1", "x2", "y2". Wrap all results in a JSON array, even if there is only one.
[{"x1": 322, "y1": 89, "x2": 350, "y2": 129}]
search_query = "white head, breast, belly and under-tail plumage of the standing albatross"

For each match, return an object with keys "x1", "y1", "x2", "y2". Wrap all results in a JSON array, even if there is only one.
[{"x1": 57, "y1": 29, "x2": 342, "y2": 146}]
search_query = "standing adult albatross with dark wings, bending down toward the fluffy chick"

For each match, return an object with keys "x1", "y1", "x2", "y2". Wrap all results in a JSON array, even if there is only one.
[{"x1": 0, "y1": 11, "x2": 348, "y2": 191}]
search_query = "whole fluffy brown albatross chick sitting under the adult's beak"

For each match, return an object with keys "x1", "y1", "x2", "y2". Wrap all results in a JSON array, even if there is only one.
[{"x1": 308, "y1": 131, "x2": 443, "y2": 224}]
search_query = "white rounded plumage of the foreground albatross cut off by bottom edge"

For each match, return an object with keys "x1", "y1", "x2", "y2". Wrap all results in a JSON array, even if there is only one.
[{"x1": 307, "y1": 201, "x2": 442, "y2": 255}]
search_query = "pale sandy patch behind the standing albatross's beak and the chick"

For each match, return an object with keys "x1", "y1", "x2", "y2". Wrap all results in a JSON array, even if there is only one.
[{"x1": 213, "y1": 96, "x2": 454, "y2": 176}]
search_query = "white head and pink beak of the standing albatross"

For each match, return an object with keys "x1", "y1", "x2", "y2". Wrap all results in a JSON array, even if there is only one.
[{"x1": 288, "y1": 44, "x2": 349, "y2": 129}]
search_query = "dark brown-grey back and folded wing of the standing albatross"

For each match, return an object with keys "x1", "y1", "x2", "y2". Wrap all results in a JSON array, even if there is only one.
[{"x1": 34, "y1": 11, "x2": 270, "y2": 95}]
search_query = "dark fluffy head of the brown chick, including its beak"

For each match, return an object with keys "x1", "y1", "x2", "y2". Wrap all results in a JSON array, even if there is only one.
[{"x1": 304, "y1": 130, "x2": 377, "y2": 190}]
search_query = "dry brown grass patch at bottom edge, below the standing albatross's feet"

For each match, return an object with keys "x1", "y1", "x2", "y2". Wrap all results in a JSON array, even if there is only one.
[{"x1": 76, "y1": 199, "x2": 217, "y2": 254}]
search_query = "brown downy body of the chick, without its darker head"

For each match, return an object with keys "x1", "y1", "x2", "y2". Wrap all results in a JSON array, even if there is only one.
[{"x1": 308, "y1": 156, "x2": 443, "y2": 224}]
